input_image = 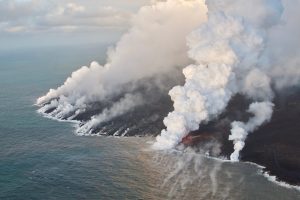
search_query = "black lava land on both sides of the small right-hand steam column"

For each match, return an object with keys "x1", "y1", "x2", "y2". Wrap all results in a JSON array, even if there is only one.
[{"x1": 184, "y1": 88, "x2": 300, "y2": 185}]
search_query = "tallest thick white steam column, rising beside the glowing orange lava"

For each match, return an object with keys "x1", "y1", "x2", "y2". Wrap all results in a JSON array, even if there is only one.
[{"x1": 154, "y1": 0, "x2": 282, "y2": 152}]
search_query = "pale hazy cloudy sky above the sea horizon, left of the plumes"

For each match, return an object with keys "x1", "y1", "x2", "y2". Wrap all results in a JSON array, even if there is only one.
[{"x1": 0, "y1": 0, "x2": 150, "y2": 49}]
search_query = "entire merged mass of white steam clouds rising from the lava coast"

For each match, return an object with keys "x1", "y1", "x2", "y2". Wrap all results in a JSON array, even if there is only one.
[{"x1": 37, "y1": 0, "x2": 300, "y2": 161}]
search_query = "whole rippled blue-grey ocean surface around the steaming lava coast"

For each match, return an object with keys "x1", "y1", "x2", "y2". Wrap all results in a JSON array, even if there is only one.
[{"x1": 0, "y1": 44, "x2": 300, "y2": 200}]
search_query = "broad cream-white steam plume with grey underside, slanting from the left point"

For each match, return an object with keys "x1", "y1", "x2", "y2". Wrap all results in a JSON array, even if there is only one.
[{"x1": 37, "y1": 0, "x2": 206, "y2": 135}]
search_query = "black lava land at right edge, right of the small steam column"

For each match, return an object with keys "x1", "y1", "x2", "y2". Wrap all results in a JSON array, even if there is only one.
[{"x1": 241, "y1": 89, "x2": 300, "y2": 185}]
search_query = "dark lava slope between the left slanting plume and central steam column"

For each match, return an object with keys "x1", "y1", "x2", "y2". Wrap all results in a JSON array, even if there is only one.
[{"x1": 74, "y1": 76, "x2": 176, "y2": 136}]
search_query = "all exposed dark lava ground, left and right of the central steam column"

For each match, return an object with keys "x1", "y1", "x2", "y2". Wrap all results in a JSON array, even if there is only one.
[{"x1": 38, "y1": 85, "x2": 300, "y2": 185}]
